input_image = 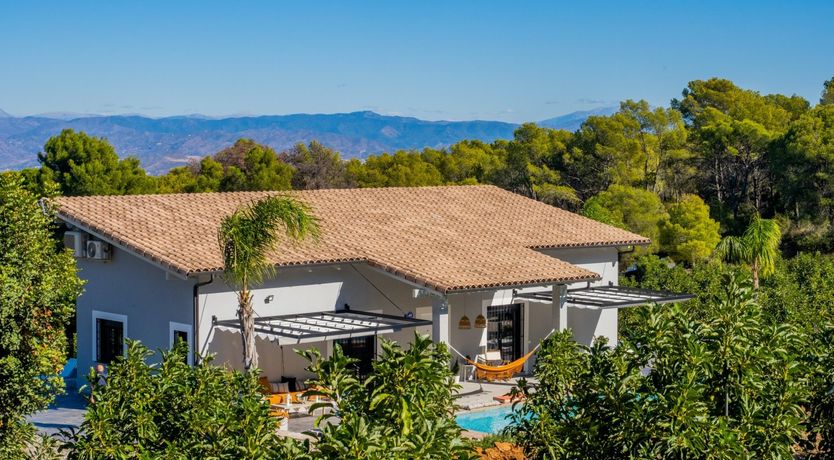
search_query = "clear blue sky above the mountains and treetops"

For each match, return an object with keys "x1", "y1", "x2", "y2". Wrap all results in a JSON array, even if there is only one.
[{"x1": 0, "y1": 0, "x2": 834, "y2": 122}]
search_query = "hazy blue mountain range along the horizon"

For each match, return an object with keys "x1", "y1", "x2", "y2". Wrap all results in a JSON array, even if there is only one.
[{"x1": 0, "y1": 108, "x2": 616, "y2": 174}]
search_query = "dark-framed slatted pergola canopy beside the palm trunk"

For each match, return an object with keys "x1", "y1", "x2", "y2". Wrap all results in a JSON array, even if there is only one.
[{"x1": 213, "y1": 309, "x2": 431, "y2": 344}]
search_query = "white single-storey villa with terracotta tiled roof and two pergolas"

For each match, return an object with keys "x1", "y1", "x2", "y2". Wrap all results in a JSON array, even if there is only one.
[{"x1": 55, "y1": 186, "x2": 687, "y2": 380}]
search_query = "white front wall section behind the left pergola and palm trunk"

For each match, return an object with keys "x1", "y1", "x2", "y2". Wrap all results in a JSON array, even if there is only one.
[{"x1": 199, "y1": 264, "x2": 432, "y2": 379}]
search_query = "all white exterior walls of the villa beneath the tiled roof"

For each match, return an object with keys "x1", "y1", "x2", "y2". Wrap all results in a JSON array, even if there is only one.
[{"x1": 77, "y1": 241, "x2": 618, "y2": 379}]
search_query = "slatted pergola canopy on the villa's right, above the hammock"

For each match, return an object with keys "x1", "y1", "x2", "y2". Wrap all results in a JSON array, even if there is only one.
[{"x1": 515, "y1": 286, "x2": 695, "y2": 310}]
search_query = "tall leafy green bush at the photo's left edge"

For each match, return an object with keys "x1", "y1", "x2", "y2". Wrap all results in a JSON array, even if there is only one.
[{"x1": 0, "y1": 173, "x2": 82, "y2": 458}]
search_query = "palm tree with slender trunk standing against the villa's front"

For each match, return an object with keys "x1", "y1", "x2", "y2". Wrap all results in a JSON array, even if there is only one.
[{"x1": 217, "y1": 196, "x2": 319, "y2": 370}]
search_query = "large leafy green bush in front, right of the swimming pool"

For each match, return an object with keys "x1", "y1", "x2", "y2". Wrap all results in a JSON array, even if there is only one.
[{"x1": 509, "y1": 276, "x2": 810, "y2": 458}]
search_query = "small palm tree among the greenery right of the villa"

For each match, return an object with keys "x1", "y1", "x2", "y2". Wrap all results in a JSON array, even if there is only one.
[{"x1": 715, "y1": 214, "x2": 782, "y2": 289}]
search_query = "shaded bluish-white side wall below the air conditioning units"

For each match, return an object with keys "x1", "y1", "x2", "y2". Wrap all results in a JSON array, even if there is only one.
[{"x1": 76, "y1": 247, "x2": 194, "y2": 376}]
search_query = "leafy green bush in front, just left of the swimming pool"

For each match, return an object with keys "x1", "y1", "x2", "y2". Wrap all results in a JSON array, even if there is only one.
[{"x1": 302, "y1": 334, "x2": 471, "y2": 459}]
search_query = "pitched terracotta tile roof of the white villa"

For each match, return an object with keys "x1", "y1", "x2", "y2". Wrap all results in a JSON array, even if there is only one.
[{"x1": 54, "y1": 185, "x2": 649, "y2": 292}]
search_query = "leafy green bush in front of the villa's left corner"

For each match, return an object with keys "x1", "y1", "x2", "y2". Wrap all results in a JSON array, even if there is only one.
[{"x1": 66, "y1": 342, "x2": 288, "y2": 459}]
